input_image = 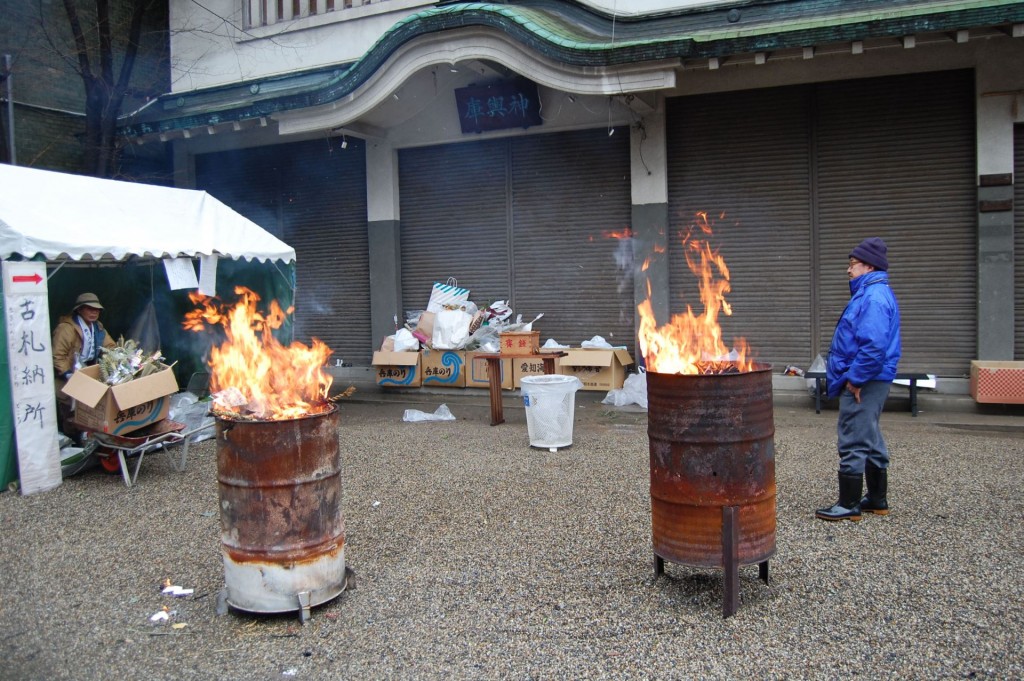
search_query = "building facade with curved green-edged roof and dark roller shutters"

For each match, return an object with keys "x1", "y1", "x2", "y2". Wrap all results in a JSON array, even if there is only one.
[{"x1": 124, "y1": 0, "x2": 1024, "y2": 378}]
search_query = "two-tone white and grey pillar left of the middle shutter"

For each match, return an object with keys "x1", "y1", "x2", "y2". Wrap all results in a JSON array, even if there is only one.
[{"x1": 367, "y1": 140, "x2": 403, "y2": 349}]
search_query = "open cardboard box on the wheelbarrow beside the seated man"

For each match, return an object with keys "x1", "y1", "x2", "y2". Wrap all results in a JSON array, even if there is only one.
[{"x1": 63, "y1": 365, "x2": 178, "y2": 435}]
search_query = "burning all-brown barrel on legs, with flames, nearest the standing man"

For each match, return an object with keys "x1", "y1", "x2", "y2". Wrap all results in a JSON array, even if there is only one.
[{"x1": 638, "y1": 214, "x2": 775, "y2": 616}]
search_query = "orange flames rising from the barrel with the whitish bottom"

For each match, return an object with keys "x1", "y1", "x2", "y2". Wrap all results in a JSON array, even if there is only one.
[{"x1": 182, "y1": 286, "x2": 334, "y2": 421}]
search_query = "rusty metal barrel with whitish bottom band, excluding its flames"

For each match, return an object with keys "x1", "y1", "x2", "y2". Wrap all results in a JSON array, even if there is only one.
[{"x1": 217, "y1": 405, "x2": 346, "y2": 612}]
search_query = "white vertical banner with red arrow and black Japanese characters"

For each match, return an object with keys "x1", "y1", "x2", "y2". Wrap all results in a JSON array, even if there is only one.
[{"x1": 3, "y1": 261, "x2": 61, "y2": 495}]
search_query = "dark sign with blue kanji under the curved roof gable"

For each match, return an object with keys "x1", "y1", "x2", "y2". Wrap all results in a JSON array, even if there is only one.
[{"x1": 455, "y1": 78, "x2": 542, "y2": 132}]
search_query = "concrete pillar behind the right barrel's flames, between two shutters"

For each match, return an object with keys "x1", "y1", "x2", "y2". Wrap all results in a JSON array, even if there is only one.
[{"x1": 630, "y1": 102, "x2": 671, "y2": 365}]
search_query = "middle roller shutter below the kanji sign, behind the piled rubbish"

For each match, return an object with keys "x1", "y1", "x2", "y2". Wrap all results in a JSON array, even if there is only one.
[{"x1": 398, "y1": 128, "x2": 634, "y2": 351}]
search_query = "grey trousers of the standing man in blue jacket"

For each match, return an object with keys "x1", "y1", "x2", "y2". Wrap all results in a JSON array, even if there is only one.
[{"x1": 838, "y1": 381, "x2": 892, "y2": 475}]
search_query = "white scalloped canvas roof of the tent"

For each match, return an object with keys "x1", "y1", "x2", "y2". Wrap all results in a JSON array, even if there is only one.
[{"x1": 0, "y1": 165, "x2": 295, "y2": 263}]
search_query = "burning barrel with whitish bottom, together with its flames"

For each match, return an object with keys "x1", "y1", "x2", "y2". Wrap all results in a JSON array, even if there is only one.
[{"x1": 185, "y1": 288, "x2": 350, "y2": 622}]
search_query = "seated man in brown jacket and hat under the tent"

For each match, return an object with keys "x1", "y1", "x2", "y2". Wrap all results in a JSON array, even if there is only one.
[{"x1": 53, "y1": 293, "x2": 115, "y2": 438}]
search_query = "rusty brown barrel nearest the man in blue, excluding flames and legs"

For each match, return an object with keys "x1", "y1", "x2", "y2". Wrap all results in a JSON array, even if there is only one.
[{"x1": 647, "y1": 365, "x2": 775, "y2": 567}]
